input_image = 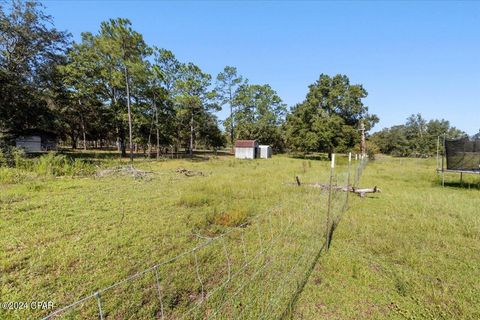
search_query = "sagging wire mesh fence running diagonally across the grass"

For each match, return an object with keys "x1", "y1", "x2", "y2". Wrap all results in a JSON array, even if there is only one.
[{"x1": 42, "y1": 154, "x2": 367, "y2": 320}]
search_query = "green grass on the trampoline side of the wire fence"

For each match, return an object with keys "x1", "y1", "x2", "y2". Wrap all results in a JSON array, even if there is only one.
[{"x1": 294, "y1": 157, "x2": 480, "y2": 319}]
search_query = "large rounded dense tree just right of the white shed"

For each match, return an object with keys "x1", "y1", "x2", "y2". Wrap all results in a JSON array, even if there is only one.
[{"x1": 285, "y1": 74, "x2": 378, "y2": 153}]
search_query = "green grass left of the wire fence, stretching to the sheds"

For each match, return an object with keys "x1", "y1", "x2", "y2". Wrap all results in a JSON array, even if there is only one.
[{"x1": 0, "y1": 156, "x2": 344, "y2": 319}]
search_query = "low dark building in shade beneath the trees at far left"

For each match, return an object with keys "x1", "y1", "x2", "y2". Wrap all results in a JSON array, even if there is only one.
[{"x1": 15, "y1": 130, "x2": 58, "y2": 153}]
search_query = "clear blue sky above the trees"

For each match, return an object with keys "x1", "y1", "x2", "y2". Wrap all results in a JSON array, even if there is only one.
[{"x1": 43, "y1": 0, "x2": 480, "y2": 134}]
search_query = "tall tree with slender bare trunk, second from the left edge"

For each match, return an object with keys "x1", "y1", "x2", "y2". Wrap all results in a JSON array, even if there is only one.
[{"x1": 61, "y1": 18, "x2": 150, "y2": 159}]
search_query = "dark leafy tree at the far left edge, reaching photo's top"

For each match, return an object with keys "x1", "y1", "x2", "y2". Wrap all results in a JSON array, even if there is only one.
[{"x1": 0, "y1": 0, "x2": 69, "y2": 134}]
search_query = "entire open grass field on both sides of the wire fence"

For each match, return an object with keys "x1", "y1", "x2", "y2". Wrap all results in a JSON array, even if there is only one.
[{"x1": 0, "y1": 156, "x2": 480, "y2": 319}]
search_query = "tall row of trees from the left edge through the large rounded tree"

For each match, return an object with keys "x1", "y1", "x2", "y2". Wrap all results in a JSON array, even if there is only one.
[{"x1": 0, "y1": 0, "x2": 378, "y2": 157}]
